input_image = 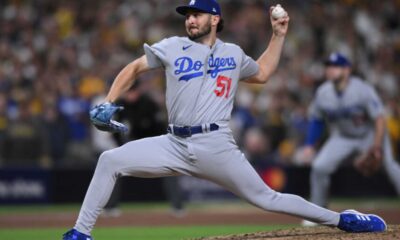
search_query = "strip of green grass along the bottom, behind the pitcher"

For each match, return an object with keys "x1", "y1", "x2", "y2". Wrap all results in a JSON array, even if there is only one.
[{"x1": 0, "y1": 225, "x2": 294, "y2": 240}]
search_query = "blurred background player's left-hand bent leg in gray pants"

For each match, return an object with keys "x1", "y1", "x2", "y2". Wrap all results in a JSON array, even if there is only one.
[{"x1": 310, "y1": 136, "x2": 355, "y2": 207}]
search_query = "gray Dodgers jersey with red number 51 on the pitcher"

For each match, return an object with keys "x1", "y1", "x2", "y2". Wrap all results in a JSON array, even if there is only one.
[{"x1": 144, "y1": 37, "x2": 258, "y2": 126}]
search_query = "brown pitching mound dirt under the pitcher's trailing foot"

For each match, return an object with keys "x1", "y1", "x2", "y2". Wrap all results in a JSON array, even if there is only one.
[{"x1": 197, "y1": 225, "x2": 400, "y2": 240}]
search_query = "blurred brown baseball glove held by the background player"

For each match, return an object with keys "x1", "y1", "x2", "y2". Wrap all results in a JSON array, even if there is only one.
[{"x1": 354, "y1": 147, "x2": 382, "y2": 176}]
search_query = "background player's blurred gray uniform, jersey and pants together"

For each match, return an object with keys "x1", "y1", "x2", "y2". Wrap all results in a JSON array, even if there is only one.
[{"x1": 309, "y1": 77, "x2": 400, "y2": 206}]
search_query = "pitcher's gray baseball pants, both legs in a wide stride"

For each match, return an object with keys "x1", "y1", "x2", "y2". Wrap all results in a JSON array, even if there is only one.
[{"x1": 75, "y1": 126, "x2": 340, "y2": 234}]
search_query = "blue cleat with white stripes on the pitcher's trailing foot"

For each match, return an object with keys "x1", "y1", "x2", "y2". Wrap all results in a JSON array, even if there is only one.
[{"x1": 338, "y1": 210, "x2": 387, "y2": 233}]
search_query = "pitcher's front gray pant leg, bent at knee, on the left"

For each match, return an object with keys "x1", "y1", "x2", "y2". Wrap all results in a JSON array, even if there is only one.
[{"x1": 74, "y1": 136, "x2": 184, "y2": 235}]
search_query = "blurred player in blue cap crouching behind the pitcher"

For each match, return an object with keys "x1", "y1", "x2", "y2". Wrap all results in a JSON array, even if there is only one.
[{"x1": 304, "y1": 53, "x2": 400, "y2": 224}]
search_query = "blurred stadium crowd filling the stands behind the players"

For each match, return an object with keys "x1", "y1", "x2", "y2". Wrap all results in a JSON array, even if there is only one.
[{"x1": 0, "y1": 0, "x2": 400, "y2": 167}]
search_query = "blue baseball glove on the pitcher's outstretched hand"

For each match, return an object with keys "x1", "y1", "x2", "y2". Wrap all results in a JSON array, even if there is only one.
[{"x1": 89, "y1": 102, "x2": 128, "y2": 133}]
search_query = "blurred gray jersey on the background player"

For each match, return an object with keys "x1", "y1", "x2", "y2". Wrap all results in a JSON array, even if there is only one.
[{"x1": 309, "y1": 77, "x2": 384, "y2": 137}]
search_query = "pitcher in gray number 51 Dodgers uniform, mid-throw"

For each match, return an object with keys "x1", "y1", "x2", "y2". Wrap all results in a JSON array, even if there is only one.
[{"x1": 64, "y1": 0, "x2": 386, "y2": 240}]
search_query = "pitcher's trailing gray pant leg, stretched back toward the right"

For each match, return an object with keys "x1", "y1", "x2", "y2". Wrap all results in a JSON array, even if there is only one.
[{"x1": 195, "y1": 150, "x2": 339, "y2": 226}]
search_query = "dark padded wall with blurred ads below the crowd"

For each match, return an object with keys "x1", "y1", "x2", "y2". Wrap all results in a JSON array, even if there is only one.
[{"x1": 0, "y1": 166, "x2": 396, "y2": 204}]
